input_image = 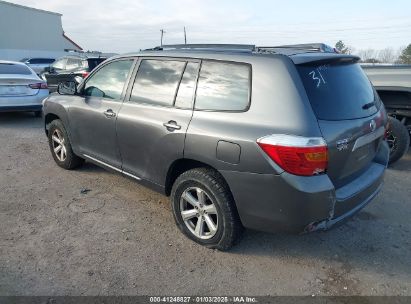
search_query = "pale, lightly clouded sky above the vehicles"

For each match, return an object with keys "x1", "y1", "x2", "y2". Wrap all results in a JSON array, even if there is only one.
[{"x1": 9, "y1": 0, "x2": 411, "y2": 53}]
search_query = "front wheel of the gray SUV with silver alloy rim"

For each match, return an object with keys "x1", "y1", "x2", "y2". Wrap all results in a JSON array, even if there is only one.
[{"x1": 48, "y1": 119, "x2": 84, "y2": 170}]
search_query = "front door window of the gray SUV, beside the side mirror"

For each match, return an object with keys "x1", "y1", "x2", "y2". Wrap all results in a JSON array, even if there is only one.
[{"x1": 83, "y1": 59, "x2": 133, "y2": 99}]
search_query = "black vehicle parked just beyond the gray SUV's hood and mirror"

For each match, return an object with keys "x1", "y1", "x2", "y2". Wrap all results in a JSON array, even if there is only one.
[{"x1": 41, "y1": 54, "x2": 107, "y2": 92}]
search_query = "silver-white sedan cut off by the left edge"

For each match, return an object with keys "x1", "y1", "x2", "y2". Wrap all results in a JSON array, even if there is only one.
[{"x1": 0, "y1": 60, "x2": 49, "y2": 116}]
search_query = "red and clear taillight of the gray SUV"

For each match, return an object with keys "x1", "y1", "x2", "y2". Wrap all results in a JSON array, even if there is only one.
[{"x1": 257, "y1": 135, "x2": 328, "y2": 176}]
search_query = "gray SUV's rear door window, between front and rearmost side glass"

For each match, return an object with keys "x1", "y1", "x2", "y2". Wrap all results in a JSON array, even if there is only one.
[{"x1": 130, "y1": 59, "x2": 186, "y2": 106}]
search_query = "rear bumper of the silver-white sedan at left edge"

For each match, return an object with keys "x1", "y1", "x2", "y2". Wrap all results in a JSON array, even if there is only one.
[{"x1": 0, "y1": 90, "x2": 49, "y2": 112}]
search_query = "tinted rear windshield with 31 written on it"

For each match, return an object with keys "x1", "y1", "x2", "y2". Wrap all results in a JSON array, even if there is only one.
[{"x1": 297, "y1": 63, "x2": 379, "y2": 120}]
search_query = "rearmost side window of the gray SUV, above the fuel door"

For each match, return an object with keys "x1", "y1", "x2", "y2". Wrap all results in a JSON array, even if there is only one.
[{"x1": 195, "y1": 61, "x2": 251, "y2": 111}]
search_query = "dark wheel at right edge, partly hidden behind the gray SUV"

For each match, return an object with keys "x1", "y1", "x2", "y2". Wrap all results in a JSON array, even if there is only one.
[{"x1": 387, "y1": 117, "x2": 410, "y2": 164}]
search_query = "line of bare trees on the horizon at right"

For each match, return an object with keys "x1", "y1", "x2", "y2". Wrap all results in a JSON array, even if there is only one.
[{"x1": 335, "y1": 40, "x2": 411, "y2": 64}]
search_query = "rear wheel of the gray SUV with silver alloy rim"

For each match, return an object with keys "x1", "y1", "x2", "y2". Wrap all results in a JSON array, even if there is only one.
[{"x1": 171, "y1": 168, "x2": 243, "y2": 251}]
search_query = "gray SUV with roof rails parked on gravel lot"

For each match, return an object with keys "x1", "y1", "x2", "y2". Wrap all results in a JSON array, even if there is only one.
[{"x1": 43, "y1": 45, "x2": 389, "y2": 250}]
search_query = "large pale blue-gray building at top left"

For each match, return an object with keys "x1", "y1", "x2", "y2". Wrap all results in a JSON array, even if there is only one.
[{"x1": 0, "y1": 0, "x2": 82, "y2": 61}]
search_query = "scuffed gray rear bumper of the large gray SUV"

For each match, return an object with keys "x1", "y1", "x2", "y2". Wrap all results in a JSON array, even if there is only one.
[{"x1": 221, "y1": 142, "x2": 389, "y2": 233}]
